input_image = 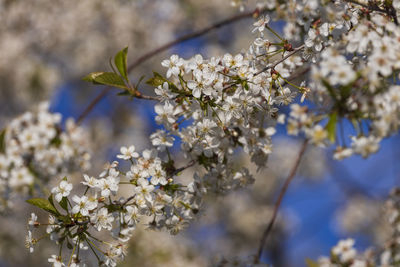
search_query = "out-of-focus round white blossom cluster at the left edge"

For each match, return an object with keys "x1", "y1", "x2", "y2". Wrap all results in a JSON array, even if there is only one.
[{"x1": 0, "y1": 102, "x2": 90, "y2": 209}]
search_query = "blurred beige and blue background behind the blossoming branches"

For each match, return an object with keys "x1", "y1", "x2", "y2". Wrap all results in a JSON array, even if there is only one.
[{"x1": 0, "y1": 0, "x2": 400, "y2": 267}]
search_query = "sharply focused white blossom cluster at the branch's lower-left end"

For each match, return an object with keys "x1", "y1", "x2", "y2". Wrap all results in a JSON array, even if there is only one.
[{"x1": 26, "y1": 146, "x2": 206, "y2": 266}]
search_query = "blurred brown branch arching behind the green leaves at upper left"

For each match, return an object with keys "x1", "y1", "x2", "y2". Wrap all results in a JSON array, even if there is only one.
[{"x1": 77, "y1": 9, "x2": 267, "y2": 124}]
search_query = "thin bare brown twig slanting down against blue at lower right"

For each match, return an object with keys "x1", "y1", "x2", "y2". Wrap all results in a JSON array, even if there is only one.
[{"x1": 254, "y1": 139, "x2": 308, "y2": 263}]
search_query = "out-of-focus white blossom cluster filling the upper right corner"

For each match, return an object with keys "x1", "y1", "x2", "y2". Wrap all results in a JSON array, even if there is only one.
[{"x1": 230, "y1": 0, "x2": 400, "y2": 159}]
